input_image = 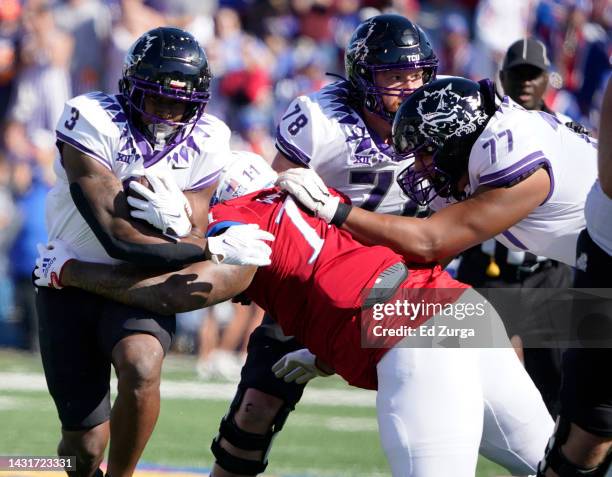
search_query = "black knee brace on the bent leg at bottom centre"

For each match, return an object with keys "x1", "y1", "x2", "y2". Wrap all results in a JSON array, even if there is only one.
[{"x1": 210, "y1": 387, "x2": 295, "y2": 475}]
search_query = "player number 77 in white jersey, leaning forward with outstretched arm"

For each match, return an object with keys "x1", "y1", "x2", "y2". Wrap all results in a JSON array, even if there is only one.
[{"x1": 279, "y1": 78, "x2": 612, "y2": 477}]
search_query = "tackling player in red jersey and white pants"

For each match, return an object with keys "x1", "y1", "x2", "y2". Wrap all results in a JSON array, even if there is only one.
[{"x1": 36, "y1": 162, "x2": 553, "y2": 477}]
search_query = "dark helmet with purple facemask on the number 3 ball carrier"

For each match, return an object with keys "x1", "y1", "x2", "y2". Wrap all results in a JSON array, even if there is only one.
[{"x1": 119, "y1": 27, "x2": 212, "y2": 141}]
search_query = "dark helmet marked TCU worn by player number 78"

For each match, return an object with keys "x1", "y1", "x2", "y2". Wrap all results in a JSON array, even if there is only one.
[{"x1": 344, "y1": 15, "x2": 438, "y2": 122}]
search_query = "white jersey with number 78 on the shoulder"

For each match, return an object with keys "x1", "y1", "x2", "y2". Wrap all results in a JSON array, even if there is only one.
[{"x1": 276, "y1": 81, "x2": 416, "y2": 215}]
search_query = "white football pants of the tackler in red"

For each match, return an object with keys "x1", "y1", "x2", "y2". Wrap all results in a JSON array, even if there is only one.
[{"x1": 376, "y1": 290, "x2": 554, "y2": 477}]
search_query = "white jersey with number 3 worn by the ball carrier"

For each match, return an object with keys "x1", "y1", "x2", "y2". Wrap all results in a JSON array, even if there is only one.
[{"x1": 46, "y1": 92, "x2": 231, "y2": 263}]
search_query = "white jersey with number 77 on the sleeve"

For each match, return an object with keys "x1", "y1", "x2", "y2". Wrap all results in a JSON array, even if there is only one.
[{"x1": 437, "y1": 97, "x2": 597, "y2": 266}]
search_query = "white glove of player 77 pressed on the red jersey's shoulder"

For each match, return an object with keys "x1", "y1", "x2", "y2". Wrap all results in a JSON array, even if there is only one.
[{"x1": 276, "y1": 167, "x2": 340, "y2": 224}]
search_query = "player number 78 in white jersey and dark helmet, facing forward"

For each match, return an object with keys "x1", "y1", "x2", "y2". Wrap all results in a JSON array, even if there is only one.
[{"x1": 273, "y1": 15, "x2": 438, "y2": 215}]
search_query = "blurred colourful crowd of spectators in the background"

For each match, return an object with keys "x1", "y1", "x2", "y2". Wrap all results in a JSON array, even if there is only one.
[{"x1": 0, "y1": 0, "x2": 612, "y2": 375}]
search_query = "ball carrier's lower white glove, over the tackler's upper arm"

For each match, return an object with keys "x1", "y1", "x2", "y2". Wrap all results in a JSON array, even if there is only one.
[{"x1": 208, "y1": 224, "x2": 274, "y2": 267}]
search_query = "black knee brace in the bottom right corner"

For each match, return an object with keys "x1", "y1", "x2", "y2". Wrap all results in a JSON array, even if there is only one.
[{"x1": 537, "y1": 416, "x2": 612, "y2": 477}]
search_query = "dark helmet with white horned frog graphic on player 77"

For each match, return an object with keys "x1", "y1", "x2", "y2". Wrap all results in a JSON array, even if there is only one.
[{"x1": 392, "y1": 77, "x2": 497, "y2": 205}]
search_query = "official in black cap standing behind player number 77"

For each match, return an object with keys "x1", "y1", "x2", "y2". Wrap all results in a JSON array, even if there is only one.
[{"x1": 457, "y1": 38, "x2": 586, "y2": 418}]
